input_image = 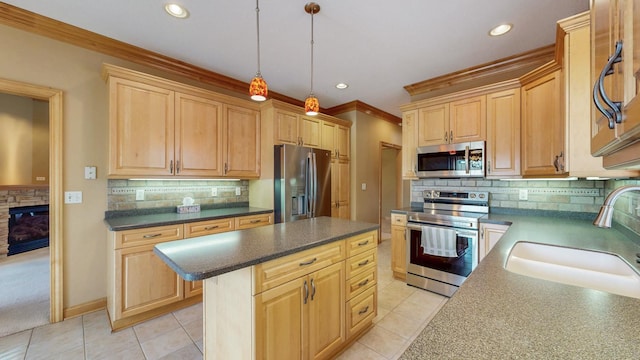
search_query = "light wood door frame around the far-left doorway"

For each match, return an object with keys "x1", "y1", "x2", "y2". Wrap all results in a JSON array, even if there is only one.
[{"x1": 0, "y1": 78, "x2": 64, "y2": 323}]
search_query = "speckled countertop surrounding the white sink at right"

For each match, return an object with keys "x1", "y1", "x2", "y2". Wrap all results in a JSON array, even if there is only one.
[{"x1": 401, "y1": 215, "x2": 640, "y2": 359}]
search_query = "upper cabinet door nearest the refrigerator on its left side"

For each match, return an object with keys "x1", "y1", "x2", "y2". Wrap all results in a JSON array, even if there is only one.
[{"x1": 223, "y1": 105, "x2": 260, "y2": 179}]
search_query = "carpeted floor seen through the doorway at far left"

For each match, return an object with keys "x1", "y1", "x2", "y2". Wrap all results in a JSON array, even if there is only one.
[{"x1": 0, "y1": 248, "x2": 50, "y2": 337}]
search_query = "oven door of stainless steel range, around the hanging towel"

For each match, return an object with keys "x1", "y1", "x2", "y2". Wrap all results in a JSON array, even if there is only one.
[{"x1": 406, "y1": 223, "x2": 478, "y2": 286}]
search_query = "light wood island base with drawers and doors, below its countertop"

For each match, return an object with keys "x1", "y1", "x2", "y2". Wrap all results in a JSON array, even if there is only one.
[{"x1": 203, "y1": 231, "x2": 378, "y2": 360}]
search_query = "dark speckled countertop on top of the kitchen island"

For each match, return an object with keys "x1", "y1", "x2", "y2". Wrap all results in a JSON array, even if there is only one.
[{"x1": 154, "y1": 217, "x2": 378, "y2": 281}]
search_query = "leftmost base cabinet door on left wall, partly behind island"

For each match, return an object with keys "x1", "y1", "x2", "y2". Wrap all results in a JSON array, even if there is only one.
[{"x1": 114, "y1": 245, "x2": 184, "y2": 319}]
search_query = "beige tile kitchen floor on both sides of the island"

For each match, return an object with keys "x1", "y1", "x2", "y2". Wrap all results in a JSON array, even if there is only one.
[{"x1": 0, "y1": 236, "x2": 447, "y2": 360}]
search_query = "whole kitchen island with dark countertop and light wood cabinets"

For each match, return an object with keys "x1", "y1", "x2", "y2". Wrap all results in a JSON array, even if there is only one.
[{"x1": 154, "y1": 217, "x2": 378, "y2": 359}]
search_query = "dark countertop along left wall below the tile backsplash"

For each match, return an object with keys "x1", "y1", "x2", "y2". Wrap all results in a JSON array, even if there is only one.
[{"x1": 104, "y1": 206, "x2": 273, "y2": 231}]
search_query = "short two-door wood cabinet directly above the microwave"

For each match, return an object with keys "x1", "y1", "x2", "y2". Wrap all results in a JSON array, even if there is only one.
[{"x1": 418, "y1": 96, "x2": 486, "y2": 146}]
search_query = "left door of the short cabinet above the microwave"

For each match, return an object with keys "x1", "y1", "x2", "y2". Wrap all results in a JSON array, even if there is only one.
[{"x1": 418, "y1": 104, "x2": 449, "y2": 146}]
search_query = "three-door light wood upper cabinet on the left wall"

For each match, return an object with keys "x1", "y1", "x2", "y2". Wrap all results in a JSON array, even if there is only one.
[{"x1": 103, "y1": 64, "x2": 260, "y2": 178}]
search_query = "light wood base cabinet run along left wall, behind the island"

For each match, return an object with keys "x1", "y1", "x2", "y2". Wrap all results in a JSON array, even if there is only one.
[{"x1": 107, "y1": 213, "x2": 273, "y2": 330}]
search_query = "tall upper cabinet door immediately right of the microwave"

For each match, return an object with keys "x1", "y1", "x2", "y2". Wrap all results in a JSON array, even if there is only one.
[{"x1": 486, "y1": 89, "x2": 520, "y2": 178}]
